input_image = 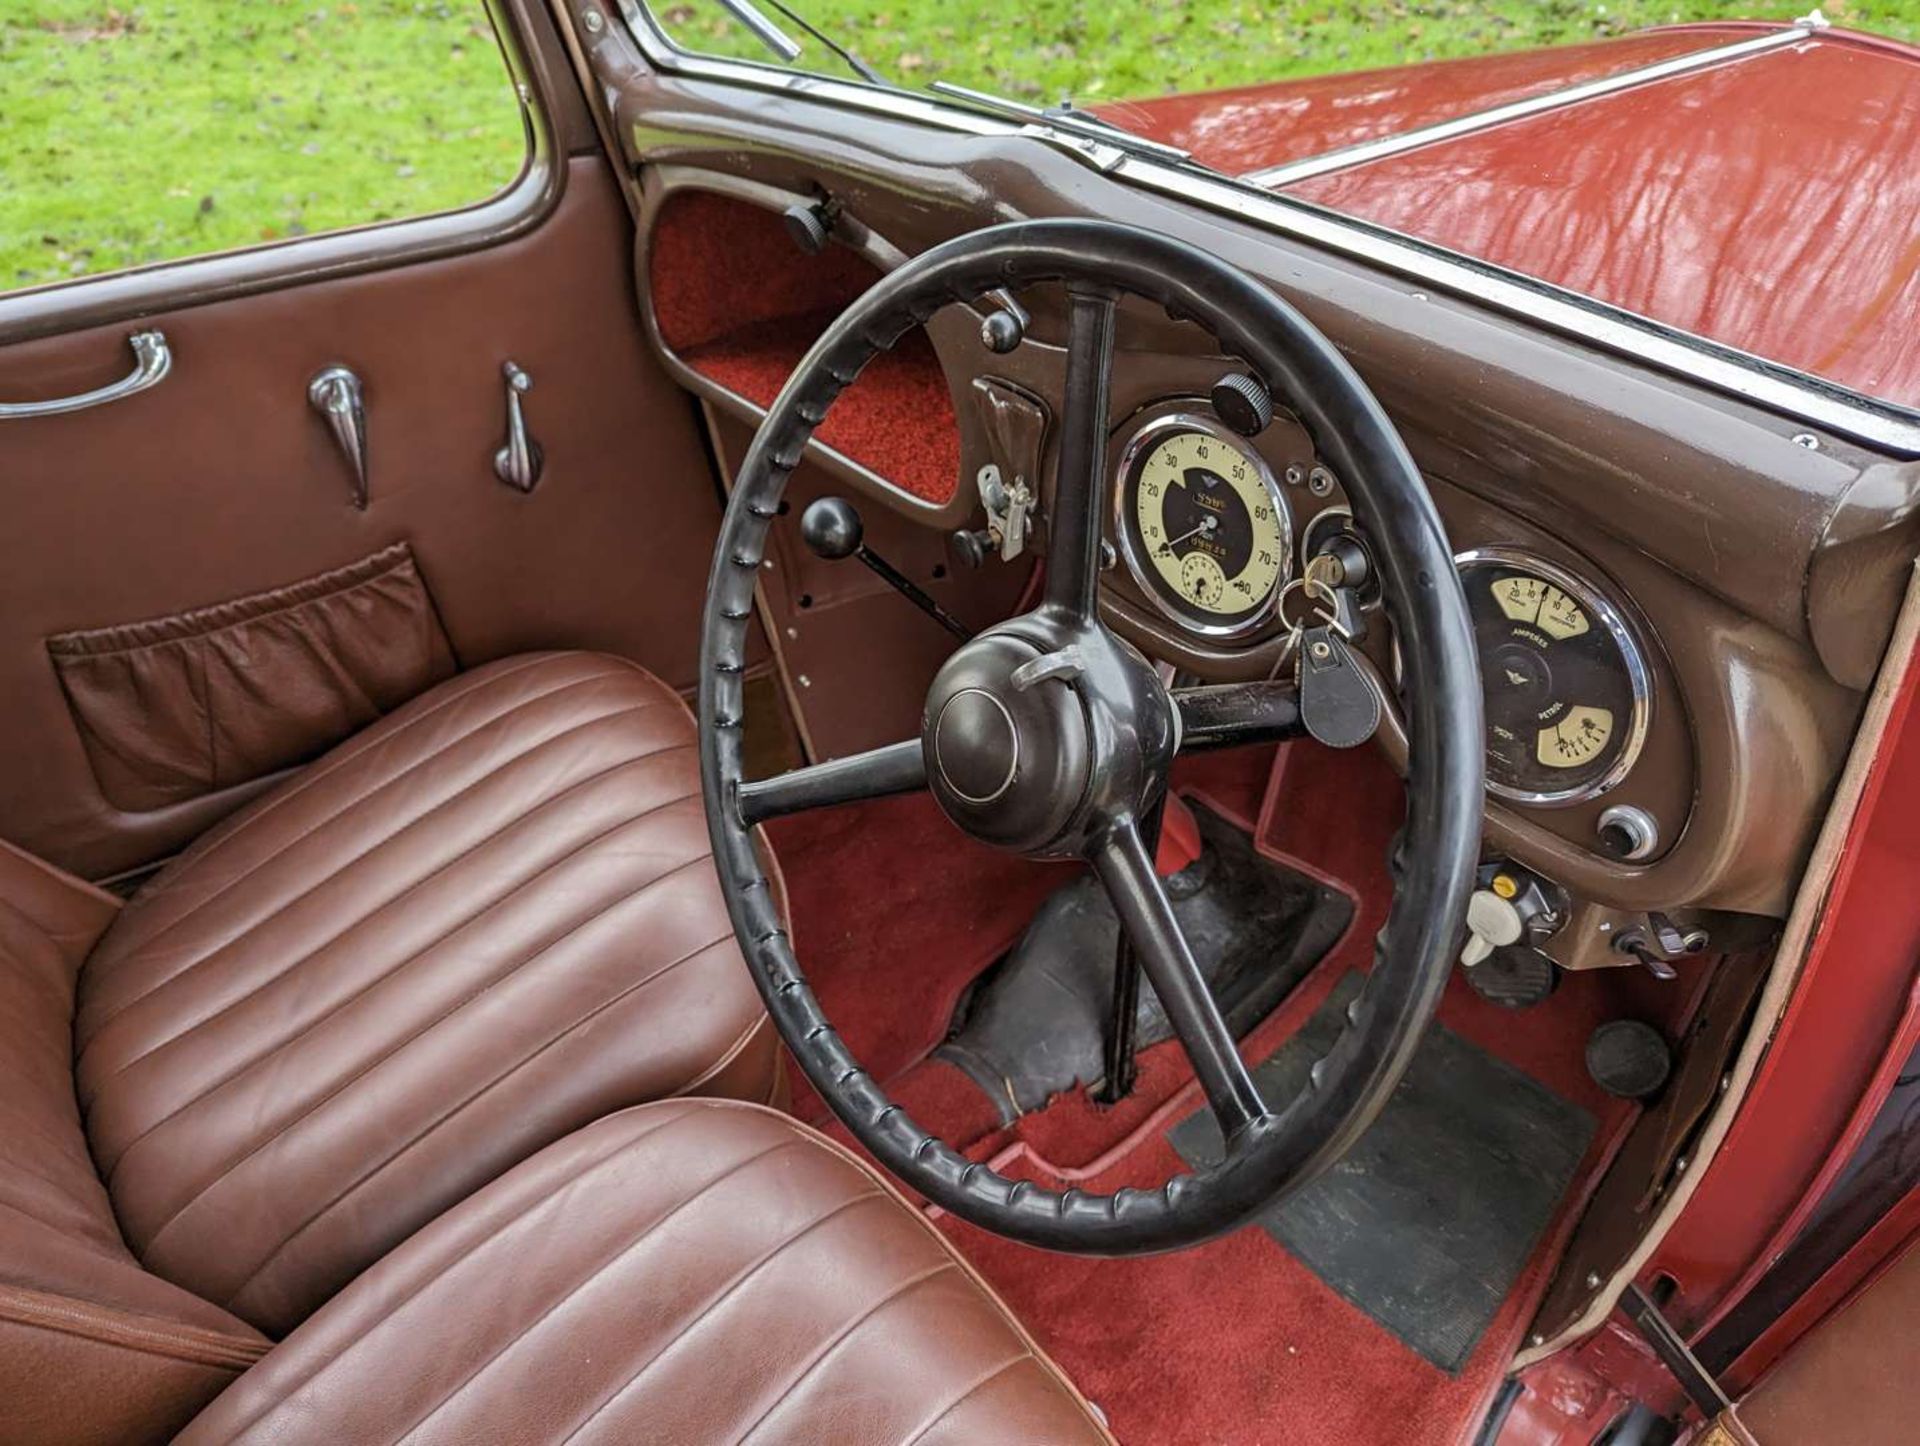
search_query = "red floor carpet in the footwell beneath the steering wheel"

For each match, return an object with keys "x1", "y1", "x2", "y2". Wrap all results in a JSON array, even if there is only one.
[{"x1": 776, "y1": 745, "x2": 1670, "y2": 1446}]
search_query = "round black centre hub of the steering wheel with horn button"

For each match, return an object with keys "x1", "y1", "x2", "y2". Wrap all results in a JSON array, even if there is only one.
[{"x1": 922, "y1": 624, "x2": 1175, "y2": 856}]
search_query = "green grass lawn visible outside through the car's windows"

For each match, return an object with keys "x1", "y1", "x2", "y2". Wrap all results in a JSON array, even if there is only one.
[{"x1": 0, "y1": 0, "x2": 1920, "y2": 290}]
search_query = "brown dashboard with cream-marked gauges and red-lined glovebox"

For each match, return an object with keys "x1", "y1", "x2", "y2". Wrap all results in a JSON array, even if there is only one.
[{"x1": 639, "y1": 168, "x2": 1899, "y2": 968}]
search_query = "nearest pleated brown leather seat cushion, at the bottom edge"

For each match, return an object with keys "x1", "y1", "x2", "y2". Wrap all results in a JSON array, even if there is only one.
[{"x1": 180, "y1": 1100, "x2": 1110, "y2": 1446}]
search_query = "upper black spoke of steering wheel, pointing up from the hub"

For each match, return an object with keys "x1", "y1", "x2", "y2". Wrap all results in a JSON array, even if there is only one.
[{"x1": 1044, "y1": 286, "x2": 1114, "y2": 618}]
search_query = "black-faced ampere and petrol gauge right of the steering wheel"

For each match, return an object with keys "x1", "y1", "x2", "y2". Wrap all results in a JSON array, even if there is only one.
[{"x1": 1457, "y1": 549, "x2": 1647, "y2": 803}]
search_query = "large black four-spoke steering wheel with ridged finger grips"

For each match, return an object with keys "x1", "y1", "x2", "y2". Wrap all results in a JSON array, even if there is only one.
[{"x1": 699, "y1": 221, "x2": 1482, "y2": 1254}]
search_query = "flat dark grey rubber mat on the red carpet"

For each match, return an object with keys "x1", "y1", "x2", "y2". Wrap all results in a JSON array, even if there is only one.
[{"x1": 1169, "y1": 974, "x2": 1596, "y2": 1371}]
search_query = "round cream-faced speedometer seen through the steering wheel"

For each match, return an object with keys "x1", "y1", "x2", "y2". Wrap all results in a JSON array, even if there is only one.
[{"x1": 1116, "y1": 415, "x2": 1292, "y2": 636}]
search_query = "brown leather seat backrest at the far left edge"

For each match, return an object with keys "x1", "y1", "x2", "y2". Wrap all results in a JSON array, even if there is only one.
[{"x1": 0, "y1": 843, "x2": 267, "y2": 1446}]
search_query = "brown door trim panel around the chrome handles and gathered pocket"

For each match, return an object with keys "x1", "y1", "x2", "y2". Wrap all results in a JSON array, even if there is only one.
[{"x1": 0, "y1": 157, "x2": 733, "y2": 878}]
